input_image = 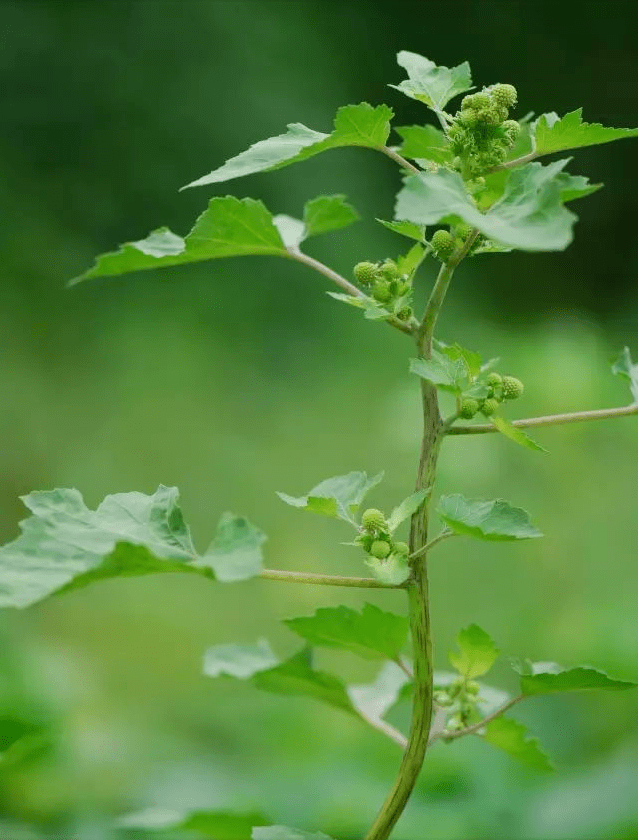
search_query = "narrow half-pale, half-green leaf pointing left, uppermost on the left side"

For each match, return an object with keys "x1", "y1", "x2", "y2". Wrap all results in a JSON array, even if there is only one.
[{"x1": 182, "y1": 102, "x2": 393, "y2": 189}]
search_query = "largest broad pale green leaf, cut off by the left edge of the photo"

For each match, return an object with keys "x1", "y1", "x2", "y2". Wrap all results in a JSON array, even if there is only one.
[{"x1": 0, "y1": 486, "x2": 264, "y2": 607}]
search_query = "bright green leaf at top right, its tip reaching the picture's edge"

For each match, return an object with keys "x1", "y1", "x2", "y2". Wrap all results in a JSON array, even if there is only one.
[{"x1": 532, "y1": 108, "x2": 638, "y2": 155}]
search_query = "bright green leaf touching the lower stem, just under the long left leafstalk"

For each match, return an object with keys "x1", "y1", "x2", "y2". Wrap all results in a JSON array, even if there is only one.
[{"x1": 284, "y1": 604, "x2": 408, "y2": 659}]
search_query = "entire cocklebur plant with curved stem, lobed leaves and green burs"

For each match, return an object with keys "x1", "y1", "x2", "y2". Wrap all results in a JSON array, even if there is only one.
[{"x1": 0, "y1": 52, "x2": 638, "y2": 840}]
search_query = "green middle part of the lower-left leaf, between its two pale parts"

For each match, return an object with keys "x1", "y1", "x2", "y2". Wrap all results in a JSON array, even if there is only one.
[{"x1": 252, "y1": 649, "x2": 356, "y2": 714}]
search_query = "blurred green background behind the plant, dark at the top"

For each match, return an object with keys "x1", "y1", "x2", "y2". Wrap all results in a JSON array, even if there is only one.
[{"x1": 0, "y1": 0, "x2": 638, "y2": 840}]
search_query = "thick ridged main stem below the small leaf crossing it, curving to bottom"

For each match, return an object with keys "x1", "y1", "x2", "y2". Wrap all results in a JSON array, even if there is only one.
[{"x1": 365, "y1": 380, "x2": 442, "y2": 840}]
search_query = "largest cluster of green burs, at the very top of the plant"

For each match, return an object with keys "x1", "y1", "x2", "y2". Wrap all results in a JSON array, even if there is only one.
[{"x1": 448, "y1": 84, "x2": 520, "y2": 179}]
